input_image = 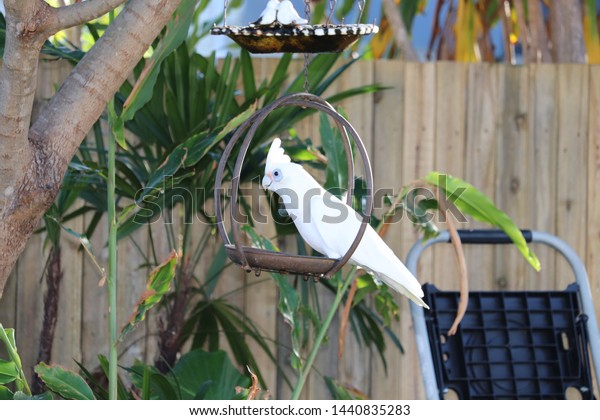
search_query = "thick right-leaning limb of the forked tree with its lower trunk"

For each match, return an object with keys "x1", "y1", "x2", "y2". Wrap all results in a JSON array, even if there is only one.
[{"x1": 0, "y1": 0, "x2": 180, "y2": 297}]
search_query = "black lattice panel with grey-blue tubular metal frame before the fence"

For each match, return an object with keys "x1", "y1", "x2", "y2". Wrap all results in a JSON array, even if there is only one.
[{"x1": 406, "y1": 230, "x2": 600, "y2": 399}]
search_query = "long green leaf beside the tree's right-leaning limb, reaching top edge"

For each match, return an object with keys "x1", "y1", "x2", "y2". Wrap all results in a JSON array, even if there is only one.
[{"x1": 121, "y1": 0, "x2": 196, "y2": 121}]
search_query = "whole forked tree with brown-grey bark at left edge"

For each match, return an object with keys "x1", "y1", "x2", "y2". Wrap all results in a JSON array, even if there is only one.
[{"x1": 0, "y1": 0, "x2": 180, "y2": 297}]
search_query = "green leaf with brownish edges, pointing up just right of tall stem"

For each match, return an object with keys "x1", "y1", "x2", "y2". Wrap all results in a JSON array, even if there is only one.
[{"x1": 120, "y1": 251, "x2": 179, "y2": 340}]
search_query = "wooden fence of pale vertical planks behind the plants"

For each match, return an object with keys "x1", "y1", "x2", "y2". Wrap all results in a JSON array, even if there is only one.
[{"x1": 0, "y1": 59, "x2": 600, "y2": 399}]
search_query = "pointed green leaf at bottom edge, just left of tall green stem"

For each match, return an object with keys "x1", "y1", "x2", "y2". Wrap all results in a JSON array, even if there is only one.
[{"x1": 34, "y1": 363, "x2": 95, "y2": 400}]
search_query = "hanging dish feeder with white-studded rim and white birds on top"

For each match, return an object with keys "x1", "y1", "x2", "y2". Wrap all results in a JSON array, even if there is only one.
[{"x1": 211, "y1": 0, "x2": 379, "y2": 54}]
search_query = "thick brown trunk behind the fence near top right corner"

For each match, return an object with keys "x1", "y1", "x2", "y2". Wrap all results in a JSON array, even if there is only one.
[{"x1": 550, "y1": 0, "x2": 586, "y2": 63}]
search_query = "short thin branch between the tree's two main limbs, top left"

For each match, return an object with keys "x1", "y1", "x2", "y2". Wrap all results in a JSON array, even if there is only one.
[{"x1": 48, "y1": 0, "x2": 126, "y2": 33}]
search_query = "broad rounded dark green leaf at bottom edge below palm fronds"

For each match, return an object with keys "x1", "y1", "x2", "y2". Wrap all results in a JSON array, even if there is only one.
[{"x1": 171, "y1": 349, "x2": 250, "y2": 400}]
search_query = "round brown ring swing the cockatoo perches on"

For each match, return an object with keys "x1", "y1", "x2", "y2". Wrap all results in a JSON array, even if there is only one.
[{"x1": 215, "y1": 93, "x2": 373, "y2": 278}]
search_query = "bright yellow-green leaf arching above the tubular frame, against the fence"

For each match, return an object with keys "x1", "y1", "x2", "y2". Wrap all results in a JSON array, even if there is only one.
[{"x1": 425, "y1": 172, "x2": 541, "y2": 271}]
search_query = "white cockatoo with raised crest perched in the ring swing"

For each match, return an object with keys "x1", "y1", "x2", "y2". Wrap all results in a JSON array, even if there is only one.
[{"x1": 262, "y1": 138, "x2": 428, "y2": 308}]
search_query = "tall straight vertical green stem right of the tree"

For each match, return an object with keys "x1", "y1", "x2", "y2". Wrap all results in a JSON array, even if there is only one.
[{"x1": 106, "y1": 99, "x2": 118, "y2": 400}]
